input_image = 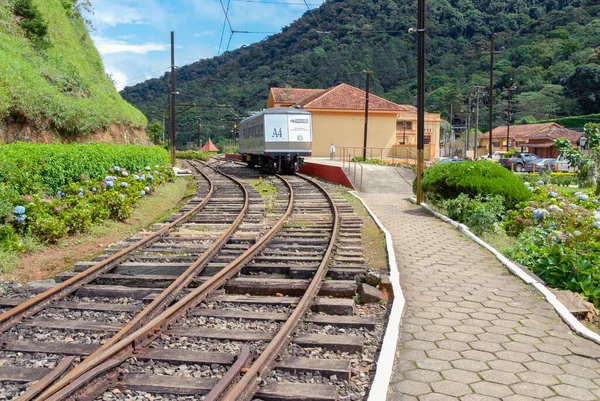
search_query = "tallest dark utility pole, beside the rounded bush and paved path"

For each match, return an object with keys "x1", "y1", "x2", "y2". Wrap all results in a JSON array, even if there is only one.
[{"x1": 417, "y1": 0, "x2": 425, "y2": 205}]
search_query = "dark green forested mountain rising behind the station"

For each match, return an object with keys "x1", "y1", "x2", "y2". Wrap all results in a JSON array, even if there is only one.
[{"x1": 122, "y1": 0, "x2": 600, "y2": 147}]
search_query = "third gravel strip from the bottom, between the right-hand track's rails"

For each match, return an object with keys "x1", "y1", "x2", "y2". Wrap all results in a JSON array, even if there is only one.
[{"x1": 150, "y1": 335, "x2": 266, "y2": 354}]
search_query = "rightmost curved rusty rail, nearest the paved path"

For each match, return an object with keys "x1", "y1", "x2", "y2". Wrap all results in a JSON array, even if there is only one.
[{"x1": 219, "y1": 175, "x2": 339, "y2": 401}]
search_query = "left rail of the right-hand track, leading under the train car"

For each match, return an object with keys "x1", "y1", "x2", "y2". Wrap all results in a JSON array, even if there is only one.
[{"x1": 37, "y1": 173, "x2": 294, "y2": 401}]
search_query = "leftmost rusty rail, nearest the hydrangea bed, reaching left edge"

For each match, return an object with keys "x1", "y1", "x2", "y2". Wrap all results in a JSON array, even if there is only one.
[{"x1": 0, "y1": 161, "x2": 214, "y2": 333}]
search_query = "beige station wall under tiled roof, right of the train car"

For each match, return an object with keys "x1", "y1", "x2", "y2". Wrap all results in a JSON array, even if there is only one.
[{"x1": 306, "y1": 109, "x2": 396, "y2": 158}]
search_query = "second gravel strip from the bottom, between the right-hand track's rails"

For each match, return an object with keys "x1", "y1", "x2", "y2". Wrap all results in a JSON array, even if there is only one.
[{"x1": 121, "y1": 358, "x2": 229, "y2": 379}]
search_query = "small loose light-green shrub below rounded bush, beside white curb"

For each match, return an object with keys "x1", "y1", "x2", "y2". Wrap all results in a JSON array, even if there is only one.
[{"x1": 442, "y1": 194, "x2": 504, "y2": 235}]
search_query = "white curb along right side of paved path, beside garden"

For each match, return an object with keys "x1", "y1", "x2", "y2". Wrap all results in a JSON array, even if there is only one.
[{"x1": 410, "y1": 198, "x2": 600, "y2": 344}]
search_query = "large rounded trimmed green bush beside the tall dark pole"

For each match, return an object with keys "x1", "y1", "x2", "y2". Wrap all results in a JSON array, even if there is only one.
[{"x1": 413, "y1": 161, "x2": 530, "y2": 209}]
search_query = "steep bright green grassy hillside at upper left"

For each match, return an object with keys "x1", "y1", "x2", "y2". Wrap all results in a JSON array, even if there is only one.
[{"x1": 0, "y1": 0, "x2": 146, "y2": 136}]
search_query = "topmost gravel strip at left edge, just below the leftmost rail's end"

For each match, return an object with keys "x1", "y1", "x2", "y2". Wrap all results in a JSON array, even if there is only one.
[{"x1": 2, "y1": 326, "x2": 114, "y2": 344}]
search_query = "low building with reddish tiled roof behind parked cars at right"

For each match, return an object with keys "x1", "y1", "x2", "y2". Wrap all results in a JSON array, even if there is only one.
[{"x1": 477, "y1": 123, "x2": 582, "y2": 158}]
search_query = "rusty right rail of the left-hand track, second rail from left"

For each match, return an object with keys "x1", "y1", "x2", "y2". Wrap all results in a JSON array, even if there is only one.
[{"x1": 17, "y1": 164, "x2": 250, "y2": 401}]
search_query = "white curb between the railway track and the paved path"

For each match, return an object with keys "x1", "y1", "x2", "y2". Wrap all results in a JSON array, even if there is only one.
[{"x1": 350, "y1": 191, "x2": 405, "y2": 401}]
